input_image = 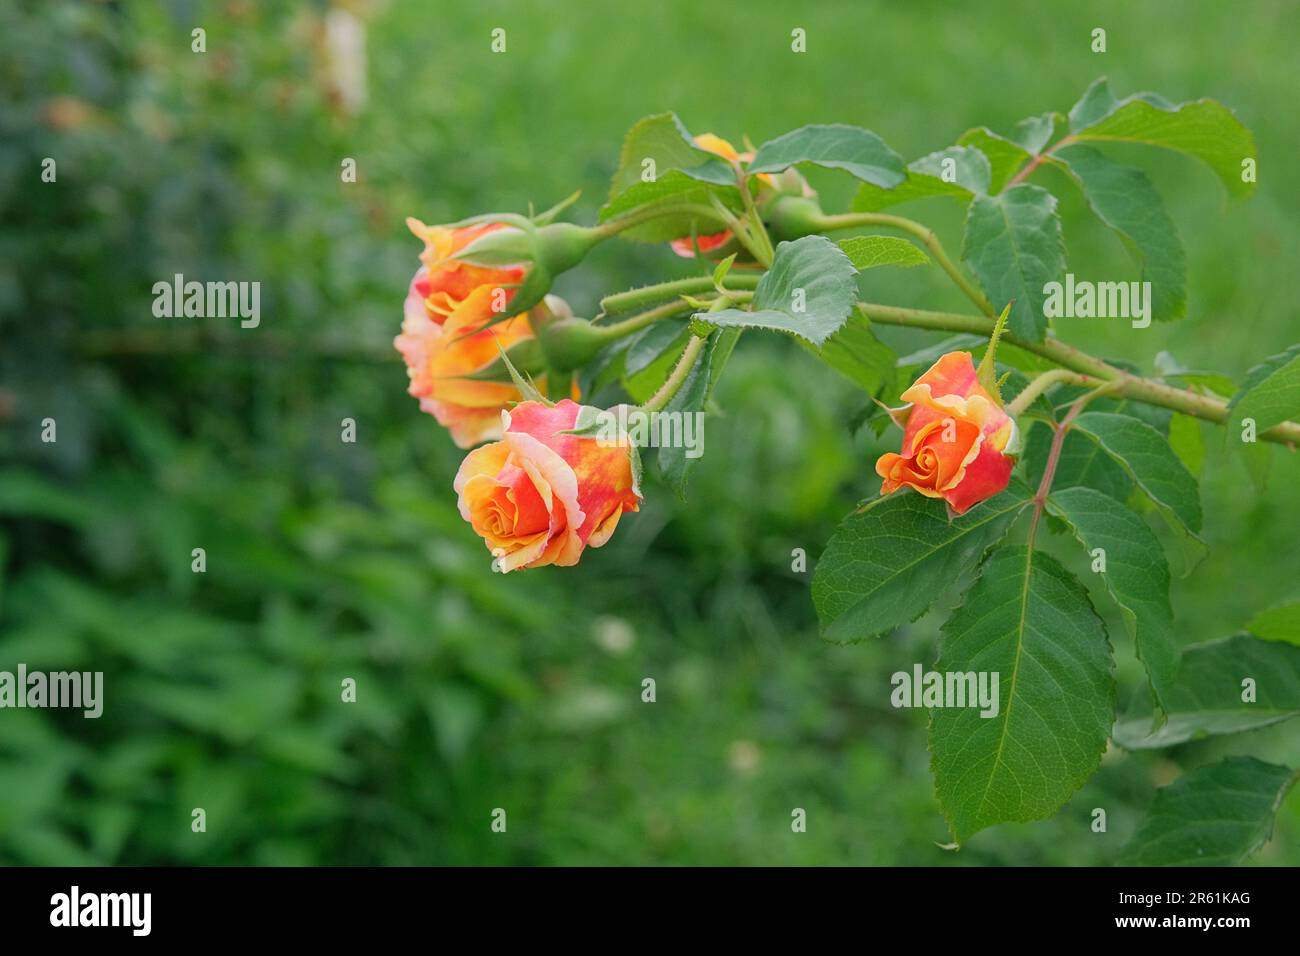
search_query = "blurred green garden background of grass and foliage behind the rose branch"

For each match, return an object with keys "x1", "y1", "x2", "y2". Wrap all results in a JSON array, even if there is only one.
[{"x1": 0, "y1": 0, "x2": 1300, "y2": 865}]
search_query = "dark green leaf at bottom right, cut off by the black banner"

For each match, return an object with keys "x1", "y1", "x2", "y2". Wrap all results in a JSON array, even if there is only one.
[{"x1": 1121, "y1": 757, "x2": 1296, "y2": 866}]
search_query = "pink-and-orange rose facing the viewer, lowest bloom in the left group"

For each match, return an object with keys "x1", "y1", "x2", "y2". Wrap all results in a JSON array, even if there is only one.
[{"x1": 454, "y1": 399, "x2": 641, "y2": 572}]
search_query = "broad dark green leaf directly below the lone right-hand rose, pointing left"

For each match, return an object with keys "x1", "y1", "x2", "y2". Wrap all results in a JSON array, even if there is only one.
[{"x1": 813, "y1": 479, "x2": 1031, "y2": 643}]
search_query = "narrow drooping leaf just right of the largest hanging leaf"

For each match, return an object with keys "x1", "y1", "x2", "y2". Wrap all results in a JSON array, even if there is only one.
[{"x1": 1048, "y1": 488, "x2": 1179, "y2": 706}]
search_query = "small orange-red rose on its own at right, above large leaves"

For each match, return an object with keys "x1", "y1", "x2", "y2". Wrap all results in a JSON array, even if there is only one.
[{"x1": 876, "y1": 352, "x2": 1015, "y2": 514}]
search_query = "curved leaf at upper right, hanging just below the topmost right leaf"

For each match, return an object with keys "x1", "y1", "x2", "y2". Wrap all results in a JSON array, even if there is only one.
[{"x1": 1056, "y1": 146, "x2": 1187, "y2": 321}]
